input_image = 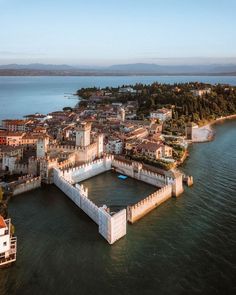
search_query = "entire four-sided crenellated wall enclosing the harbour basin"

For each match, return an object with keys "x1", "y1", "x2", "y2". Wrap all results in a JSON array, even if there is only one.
[{"x1": 53, "y1": 156, "x2": 186, "y2": 244}]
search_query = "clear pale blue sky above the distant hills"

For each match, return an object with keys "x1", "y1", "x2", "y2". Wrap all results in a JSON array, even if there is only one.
[{"x1": 0, "y1": 0, "x2": 236, "y2": 66}]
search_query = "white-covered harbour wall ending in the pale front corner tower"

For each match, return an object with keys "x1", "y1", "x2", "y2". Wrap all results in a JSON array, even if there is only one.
[{"x1": 53, "y1": 168, "x2": 126, "y2": 244}]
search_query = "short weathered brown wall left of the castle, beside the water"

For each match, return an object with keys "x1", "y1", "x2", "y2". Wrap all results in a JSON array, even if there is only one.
[{"x1": 10, "y1": 175, "x2": 41, "y2": 196}]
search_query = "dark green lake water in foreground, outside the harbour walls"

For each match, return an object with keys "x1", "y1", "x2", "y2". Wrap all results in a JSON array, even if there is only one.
[{"x1": 0, "y1": 121, "x2": 236, "y2": 295}]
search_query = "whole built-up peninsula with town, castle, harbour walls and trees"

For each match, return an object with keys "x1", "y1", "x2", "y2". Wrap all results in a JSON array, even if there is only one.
[{"x1": 0, "y1": 83, "x2": 236, "y2": 265}]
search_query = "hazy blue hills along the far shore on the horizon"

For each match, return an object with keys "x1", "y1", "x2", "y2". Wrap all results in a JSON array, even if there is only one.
[{"x1": 0, "y1": 63, "x2": 236, "y2": 76}]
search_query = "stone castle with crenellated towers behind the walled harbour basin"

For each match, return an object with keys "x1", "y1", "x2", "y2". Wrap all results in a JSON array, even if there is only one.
[{"x1": 2, "y1": 122, "x2": 103, "y2": 183}]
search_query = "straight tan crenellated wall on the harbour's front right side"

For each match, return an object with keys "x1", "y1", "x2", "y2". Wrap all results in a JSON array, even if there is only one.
[{"x1": 127, "y1": 185, "x2": 172, "y2": 223}]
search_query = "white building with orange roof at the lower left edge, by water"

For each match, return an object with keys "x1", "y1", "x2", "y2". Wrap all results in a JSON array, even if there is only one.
[{"x1": 0, "y1": 215, "x2": 17, "y2": 267}]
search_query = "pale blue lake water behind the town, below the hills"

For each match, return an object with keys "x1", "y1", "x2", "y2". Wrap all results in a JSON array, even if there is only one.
[{"x1": 0, "y1": 76, "x2": 236, "y2": 120}]
